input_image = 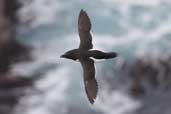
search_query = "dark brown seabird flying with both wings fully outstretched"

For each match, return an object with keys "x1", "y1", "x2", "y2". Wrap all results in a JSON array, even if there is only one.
[{"x1": 61, "y1": 10, "x2": 117, "y2": 104}]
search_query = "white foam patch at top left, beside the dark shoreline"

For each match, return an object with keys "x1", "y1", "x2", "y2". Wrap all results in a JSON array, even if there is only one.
[{"x1": 19, "y1": 0, "x2": 62, "y2": 28}]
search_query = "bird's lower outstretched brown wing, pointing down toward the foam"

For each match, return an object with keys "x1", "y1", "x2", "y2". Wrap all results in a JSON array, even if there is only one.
[{"x1": 80, "y1": 58, "x2": 98, "y2": 104}]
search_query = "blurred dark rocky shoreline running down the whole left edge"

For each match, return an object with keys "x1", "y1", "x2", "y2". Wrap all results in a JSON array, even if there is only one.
[{"x1": 0, "y1": 0, "x2": 32, "y2": 114}]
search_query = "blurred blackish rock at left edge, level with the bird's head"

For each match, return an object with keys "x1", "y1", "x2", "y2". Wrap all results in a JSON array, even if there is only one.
[{"x1": 0, "y1": 40, "x2": 31, "y2": 73}]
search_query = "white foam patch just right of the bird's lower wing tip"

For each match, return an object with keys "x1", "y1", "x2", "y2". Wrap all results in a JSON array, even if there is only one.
[{"x1": 95, "y1": 89, "x2": 141, "y2": 114}]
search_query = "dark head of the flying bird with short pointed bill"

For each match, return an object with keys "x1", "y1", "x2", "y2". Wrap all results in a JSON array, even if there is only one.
[{"x1": 60, "y1": 50, "x2": 77, "y2": 61}]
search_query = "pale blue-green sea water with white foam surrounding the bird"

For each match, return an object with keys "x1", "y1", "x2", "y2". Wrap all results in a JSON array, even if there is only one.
[{"x1": 14, "y1": 0, "x2": 171, "y2": 114}]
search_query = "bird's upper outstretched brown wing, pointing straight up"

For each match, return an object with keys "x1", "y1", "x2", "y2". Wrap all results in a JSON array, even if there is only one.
[{"x1": 78, "y1": 10, "x2": 93, "y2": 50}]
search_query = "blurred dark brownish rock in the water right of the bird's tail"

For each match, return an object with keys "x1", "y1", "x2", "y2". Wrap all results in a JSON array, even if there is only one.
[{"x1": 122, "y1": 56, "x2": 171, "y2": 96}]
